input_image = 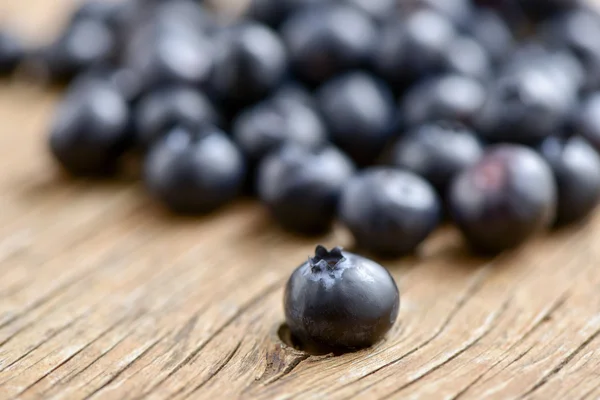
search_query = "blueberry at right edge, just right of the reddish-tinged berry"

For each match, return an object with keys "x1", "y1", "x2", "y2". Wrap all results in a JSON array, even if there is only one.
[{"x1": 539, "y1": 137, "x2": 600, "y2": 225}]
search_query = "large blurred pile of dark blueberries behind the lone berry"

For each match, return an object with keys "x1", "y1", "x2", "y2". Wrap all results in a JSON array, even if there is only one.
[{"x1": 0, "y1": 0, "x2": 600, "y2": 257}]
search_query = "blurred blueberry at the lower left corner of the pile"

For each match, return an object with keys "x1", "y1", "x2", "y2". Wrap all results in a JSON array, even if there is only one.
[{"x1": 50, "y1": 81, "x2": 132, "y2": 175}]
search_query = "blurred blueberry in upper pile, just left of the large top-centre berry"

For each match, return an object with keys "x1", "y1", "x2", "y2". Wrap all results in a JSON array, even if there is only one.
[{"x1": 211, "y1": 22, "x2": 287, "y2": 109}]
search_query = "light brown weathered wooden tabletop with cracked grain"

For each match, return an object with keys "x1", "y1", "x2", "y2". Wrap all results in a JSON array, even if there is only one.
[{"x1": 0, "y1": 0, "x2": 600, "y2": 400}]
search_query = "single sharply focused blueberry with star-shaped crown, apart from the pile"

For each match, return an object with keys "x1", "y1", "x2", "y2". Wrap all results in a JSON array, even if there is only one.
[{"x1": 284, "y1": 246, "x2": 400, "y2": 350}]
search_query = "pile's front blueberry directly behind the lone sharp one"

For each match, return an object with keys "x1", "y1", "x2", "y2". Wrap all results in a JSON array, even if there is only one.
[{"x1": 338, "y1": 167, "x2": 441, "y2": 257}]
